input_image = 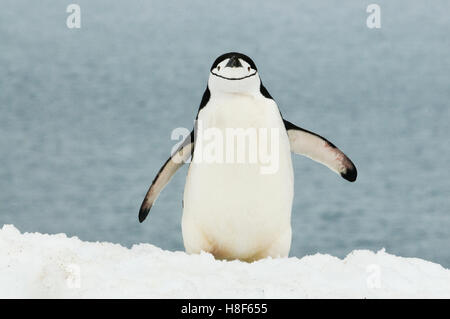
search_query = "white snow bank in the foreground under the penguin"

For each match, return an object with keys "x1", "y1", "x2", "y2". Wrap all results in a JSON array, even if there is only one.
[{"x1": 0, "y1": 225, "x2": 450, "y2": 298}]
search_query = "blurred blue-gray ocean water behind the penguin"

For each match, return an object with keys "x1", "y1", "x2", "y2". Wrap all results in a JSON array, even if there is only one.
[{"x1": 0, "y1": 0, "x2": 450, "y2": 267}]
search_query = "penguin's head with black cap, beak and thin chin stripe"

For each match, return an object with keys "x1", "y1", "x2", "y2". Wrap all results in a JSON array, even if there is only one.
[{"x1": 208, "y1": 52, "x2": 261, "y2": 94}]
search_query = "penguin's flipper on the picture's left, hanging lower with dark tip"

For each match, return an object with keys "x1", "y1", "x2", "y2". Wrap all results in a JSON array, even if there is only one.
[{"x1": 139, "y1": 131, "x2": 194, "y2": 223}]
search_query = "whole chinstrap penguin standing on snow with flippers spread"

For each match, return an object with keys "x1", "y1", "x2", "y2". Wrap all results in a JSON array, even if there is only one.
[{"x1": 139, "y1": 52, "x2": 357, "y2": 262}]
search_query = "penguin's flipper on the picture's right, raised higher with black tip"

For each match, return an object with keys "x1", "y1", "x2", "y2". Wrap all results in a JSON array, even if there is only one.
[{"x1": 283, "y1": 120, "x2": 357, "y2": 182}]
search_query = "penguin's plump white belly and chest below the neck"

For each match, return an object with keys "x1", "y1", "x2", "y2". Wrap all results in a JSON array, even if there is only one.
[{"x1": 182, "y1": 96, "x2": 294, "y2": 261}]
